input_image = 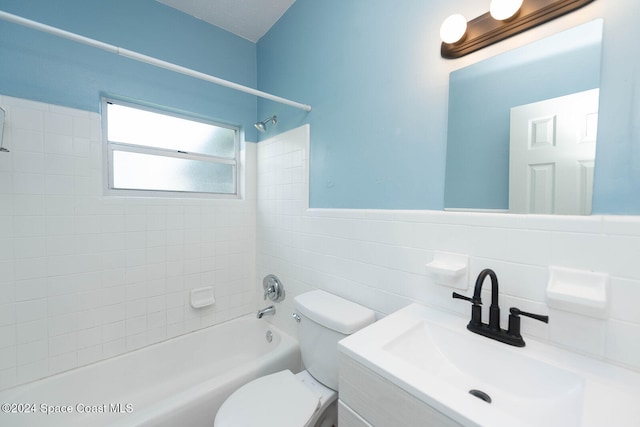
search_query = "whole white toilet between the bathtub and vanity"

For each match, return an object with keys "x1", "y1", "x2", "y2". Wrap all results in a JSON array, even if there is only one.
[{"x1": 214, "y1": 290, "x2": 375, "y2": 427}]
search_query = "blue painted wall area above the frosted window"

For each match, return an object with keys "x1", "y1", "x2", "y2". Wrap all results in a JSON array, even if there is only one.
[{"x1": 0, "y1": 0, "x2": 257, "y2": 141}]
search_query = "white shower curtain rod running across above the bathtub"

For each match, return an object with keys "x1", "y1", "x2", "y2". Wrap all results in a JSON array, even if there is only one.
[{"x1": 0, "y1": 10, "x2": 311, "y2": 111}]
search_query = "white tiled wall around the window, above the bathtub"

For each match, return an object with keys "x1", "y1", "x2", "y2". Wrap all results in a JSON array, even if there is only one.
[{"x1": 0, "y1": 96, "x2": 256, "y2": 390}]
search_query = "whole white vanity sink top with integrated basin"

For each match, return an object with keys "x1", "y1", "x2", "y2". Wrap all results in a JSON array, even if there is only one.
[{"x1": 339, "y1": 304, "x2": 640, "y2": 427}]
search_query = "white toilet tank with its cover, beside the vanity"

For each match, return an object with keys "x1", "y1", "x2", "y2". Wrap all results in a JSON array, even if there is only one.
[{"x1": 294, "y1": 290, "x2": 376, "y2": 390}]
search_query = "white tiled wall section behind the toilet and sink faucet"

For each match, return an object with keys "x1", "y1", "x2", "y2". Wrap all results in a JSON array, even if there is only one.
[{"x1": 257, "y1": 127, "x2": 640, "y2": 370}]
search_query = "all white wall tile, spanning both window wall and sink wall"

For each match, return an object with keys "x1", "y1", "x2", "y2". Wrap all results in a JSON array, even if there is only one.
[{"x1": 0, "y1": 97, "x2": 640, "y2": 389}]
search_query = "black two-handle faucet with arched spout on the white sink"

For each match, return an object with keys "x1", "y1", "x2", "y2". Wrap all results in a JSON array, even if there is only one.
[{"x1": 453, "y1": 268, "x2": 549, "y2": 347}]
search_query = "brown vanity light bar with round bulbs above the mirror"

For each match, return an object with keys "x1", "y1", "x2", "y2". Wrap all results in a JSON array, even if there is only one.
[{"x1": 440, "y1": 0, "x2": 594, "y2": 59}]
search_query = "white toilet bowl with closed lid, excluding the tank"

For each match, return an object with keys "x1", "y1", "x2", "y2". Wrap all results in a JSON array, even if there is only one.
[{"x1": 214, "y1": 370, "x2": 338, "y2": 427}]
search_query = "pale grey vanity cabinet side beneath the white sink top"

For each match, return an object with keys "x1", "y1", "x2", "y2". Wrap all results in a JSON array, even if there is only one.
[{"x1": 338, "y1": 353, "x2": 461, "y2": 427}]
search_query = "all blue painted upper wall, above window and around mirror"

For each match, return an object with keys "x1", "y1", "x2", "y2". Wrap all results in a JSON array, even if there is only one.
[{"x1": 0, "y1": 0, "x2": 640, "y2": 213}]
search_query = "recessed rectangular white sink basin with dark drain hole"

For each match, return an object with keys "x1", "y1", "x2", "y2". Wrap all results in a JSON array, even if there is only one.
[{"x1": 382, "y1": 321, "x2": 584, "y2": 427}]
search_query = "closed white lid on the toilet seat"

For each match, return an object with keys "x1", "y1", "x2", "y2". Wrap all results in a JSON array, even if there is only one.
[{"x1": 214, "y1": 370, "x2": 320, "y2": 427}]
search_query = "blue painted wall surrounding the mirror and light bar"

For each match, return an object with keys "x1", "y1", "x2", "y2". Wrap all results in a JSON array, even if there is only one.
[{"x1": 258, "y1": 0, "x2": 640, "y2": 213}]
